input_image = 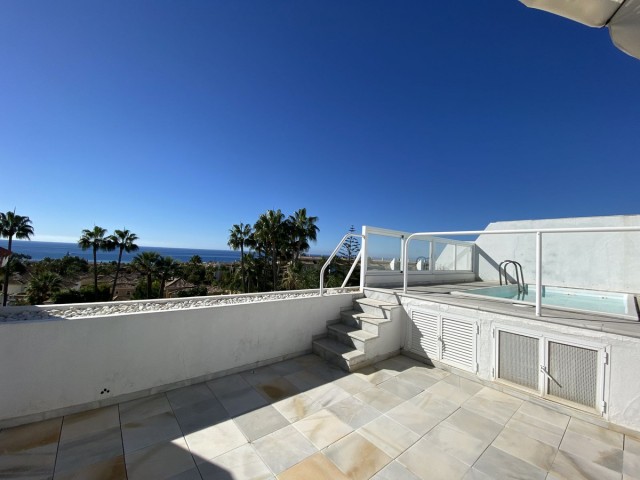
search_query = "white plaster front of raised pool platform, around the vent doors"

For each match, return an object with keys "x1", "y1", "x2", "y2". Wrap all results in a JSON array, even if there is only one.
[{"x1": 402, "y1": 297, "x2": 640, "y2": 431}]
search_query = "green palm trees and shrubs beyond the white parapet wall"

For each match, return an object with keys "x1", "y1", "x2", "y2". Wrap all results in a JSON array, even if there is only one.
[{"x1": 0, "y1": 208, "x2": 360, "y2": 304}]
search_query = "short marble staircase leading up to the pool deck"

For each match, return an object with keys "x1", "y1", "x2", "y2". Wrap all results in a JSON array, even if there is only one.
[{"x1": 313, "y1": 297, "x2": 399, "y2": 372}]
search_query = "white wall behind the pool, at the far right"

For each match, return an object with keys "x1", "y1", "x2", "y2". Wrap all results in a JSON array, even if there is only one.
[{"x1": 476, "y1": 215, "x2": 640, "y2": 293}]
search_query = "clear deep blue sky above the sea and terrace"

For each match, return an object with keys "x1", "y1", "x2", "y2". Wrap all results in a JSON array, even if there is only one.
[{"x1": 0, "y1": 0, "x2": 640, "y2": 252}]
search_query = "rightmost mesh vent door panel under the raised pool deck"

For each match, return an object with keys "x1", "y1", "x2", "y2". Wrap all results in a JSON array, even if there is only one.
[{"x1": 547, "y1": 342, "x2": 598, "y2": 408}]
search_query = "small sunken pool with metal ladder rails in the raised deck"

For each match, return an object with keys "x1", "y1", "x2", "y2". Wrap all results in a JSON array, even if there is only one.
[{"x1": 451, "y1": 284, "x2": 638, "y2": 321}]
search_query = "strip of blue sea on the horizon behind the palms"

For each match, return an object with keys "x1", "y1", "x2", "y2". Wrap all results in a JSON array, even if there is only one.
[{"x1": 0, "y1": 239, "x2": 240, "y2": 263}]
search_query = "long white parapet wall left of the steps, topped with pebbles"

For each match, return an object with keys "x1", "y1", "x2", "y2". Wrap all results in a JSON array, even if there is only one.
[{"x1": 0, "y1": 294, "x2": 354, "y2": 427}]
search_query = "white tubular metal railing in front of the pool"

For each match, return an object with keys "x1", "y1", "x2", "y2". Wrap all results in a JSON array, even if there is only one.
[{"x1": 402, "y1": 227, "x2": 640, "y2": 317}]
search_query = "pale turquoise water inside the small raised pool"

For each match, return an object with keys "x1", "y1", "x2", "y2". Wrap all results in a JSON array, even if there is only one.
[{"x1": 465, "y1": 285, "x2": 629, "y2": 315}]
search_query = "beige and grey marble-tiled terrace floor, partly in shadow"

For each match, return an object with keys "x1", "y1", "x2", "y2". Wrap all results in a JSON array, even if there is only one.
[{"x1": 0, "y1": 355, "x2": 640, "y2": 480}]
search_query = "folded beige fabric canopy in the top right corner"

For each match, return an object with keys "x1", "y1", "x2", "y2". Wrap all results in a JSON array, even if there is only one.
[{"x1": 520, "y1": 0, "x2": 640, "y2": 59}]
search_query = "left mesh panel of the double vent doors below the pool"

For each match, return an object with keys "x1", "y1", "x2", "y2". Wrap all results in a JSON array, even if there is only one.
[{"x1": 498, "y1": 331, "x2": 540, "y2": 390}]
